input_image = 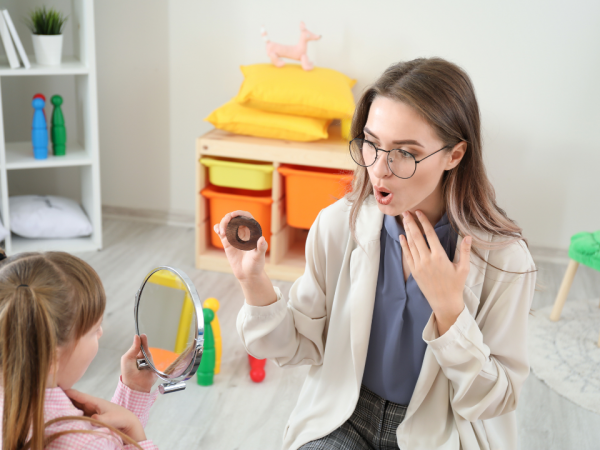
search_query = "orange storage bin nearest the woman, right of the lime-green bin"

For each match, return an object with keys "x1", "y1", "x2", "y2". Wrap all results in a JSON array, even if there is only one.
[{"x1": 277, "y1": 166, "x2": 353, "y2": 230}]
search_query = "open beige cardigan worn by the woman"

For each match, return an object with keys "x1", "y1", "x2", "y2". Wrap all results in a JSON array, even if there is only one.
[{"x1": 237, "y1": 196, "x2": 536, "y2": 450}]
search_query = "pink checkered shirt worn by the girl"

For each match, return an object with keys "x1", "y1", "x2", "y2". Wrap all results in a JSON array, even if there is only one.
[{"x1": 0, "y1": 380, "x2": 158, "y2": 450}]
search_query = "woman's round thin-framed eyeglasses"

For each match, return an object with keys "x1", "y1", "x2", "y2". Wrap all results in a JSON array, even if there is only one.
[{"x1": 350, "y1": 138, "x2": 450, "y2": 179}]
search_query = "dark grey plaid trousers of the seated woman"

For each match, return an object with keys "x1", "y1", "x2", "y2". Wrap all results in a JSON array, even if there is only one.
[{"x1": 300, "y1": 386, "x2": 406, "y2": 450}]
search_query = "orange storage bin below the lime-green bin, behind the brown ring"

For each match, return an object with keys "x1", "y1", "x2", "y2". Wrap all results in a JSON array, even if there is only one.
[{"x1": 200, "y1": 186, "x2": 273, "y2": 248}]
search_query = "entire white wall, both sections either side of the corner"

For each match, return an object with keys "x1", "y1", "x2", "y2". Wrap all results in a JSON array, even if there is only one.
[{"x1": 3, "y1": 0, "x2": 600, "y2": 248}]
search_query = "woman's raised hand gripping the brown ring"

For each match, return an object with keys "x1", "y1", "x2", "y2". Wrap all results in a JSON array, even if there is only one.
[{"x1": 214, "y1": 211, "x2": 269, "y2": 283}]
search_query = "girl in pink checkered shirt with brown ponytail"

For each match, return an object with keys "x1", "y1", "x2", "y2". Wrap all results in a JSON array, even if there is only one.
[{"x1": 0, "y1": 252, "x2": 157, "y2": 450}]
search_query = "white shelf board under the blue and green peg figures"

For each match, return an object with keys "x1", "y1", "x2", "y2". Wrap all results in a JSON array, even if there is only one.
[{"x1": 6, "y1": 142, "x2": 93, "y2": 170}]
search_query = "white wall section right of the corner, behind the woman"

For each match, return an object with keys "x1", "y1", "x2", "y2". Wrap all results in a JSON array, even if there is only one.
[{"x1": 169, "y1": 0, "x2": 600, "y2": 248}]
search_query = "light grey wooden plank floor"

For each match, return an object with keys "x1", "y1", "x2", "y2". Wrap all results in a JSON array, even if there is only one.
[{"x1": 75, "y1": 219, "x2": 600, "y2": 450}]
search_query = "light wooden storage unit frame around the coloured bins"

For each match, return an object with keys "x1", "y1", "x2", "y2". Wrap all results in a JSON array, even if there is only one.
[{"x1": 196, "y1": 126, "x2": 355, "y2": 281}]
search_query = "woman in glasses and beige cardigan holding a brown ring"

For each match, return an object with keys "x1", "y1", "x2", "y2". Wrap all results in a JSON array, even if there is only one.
[{"x1": 215, "y1": 58, "x2": 536, "y2": 450}]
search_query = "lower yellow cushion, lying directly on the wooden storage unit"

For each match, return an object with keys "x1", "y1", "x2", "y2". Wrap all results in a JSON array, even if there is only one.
[{"x1": 204, "y1": 100, "x2": 331, "y2": 141}]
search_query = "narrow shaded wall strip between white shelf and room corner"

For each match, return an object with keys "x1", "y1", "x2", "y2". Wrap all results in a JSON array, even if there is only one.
[{"x1": 95, "y1": 0, "x2": 171, "y2": 211}]
